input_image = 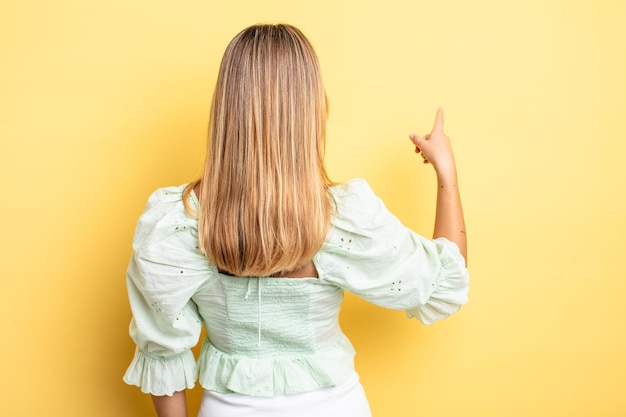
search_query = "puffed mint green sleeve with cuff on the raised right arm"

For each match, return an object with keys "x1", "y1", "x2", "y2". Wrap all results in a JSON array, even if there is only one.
[{"x1": 314, "y1": 179, "x2": 469, "y2": 325}]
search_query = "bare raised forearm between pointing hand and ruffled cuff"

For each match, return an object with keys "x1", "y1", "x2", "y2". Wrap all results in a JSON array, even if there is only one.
[{"x1": 433, "y1": 166, "x2": 467, "y2": 265}]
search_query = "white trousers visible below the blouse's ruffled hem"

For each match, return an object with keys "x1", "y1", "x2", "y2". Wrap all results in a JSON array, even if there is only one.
[{"x1": 198, "y1": 373, "x2": 372, "y2": 417}]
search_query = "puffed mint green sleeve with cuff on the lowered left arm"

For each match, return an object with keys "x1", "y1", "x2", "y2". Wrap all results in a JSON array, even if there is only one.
[{"x1": 124, "y1": 187, "x2": 210, "y2": 395}]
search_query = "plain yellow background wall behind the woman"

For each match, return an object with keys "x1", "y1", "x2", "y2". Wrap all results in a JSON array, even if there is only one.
[{"x1": 0, "y1": 0, "x2": 626, "y2": 417}]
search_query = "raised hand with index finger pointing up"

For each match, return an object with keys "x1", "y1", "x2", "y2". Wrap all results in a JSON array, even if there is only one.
[{"x1": 409, "y1": 107, "x2": 455, "y2": 172}]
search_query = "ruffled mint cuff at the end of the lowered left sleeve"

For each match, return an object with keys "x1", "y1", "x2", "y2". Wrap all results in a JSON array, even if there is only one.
[{"x1": 124, "y1": 349, "x2": 198, "y2": 396}]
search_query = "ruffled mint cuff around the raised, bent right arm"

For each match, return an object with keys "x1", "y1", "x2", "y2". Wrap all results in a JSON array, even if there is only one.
[{"x1": 406, "y1": 238, "x2": 469, "y2": 325}]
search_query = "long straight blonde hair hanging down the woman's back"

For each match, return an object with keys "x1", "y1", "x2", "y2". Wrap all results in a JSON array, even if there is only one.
[{"x1": 184, "y1": 24, "x2": 331, "y2": 276}]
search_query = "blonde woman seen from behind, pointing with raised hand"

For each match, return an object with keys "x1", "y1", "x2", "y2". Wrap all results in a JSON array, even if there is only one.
[{"x1": 124, "y1": 25, "x2": 468, "y2": 417}]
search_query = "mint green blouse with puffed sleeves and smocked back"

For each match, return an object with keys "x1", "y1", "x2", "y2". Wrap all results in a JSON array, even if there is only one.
[{"x1": 124, "y1": 179, "x2": 469, "y2": 397}]
